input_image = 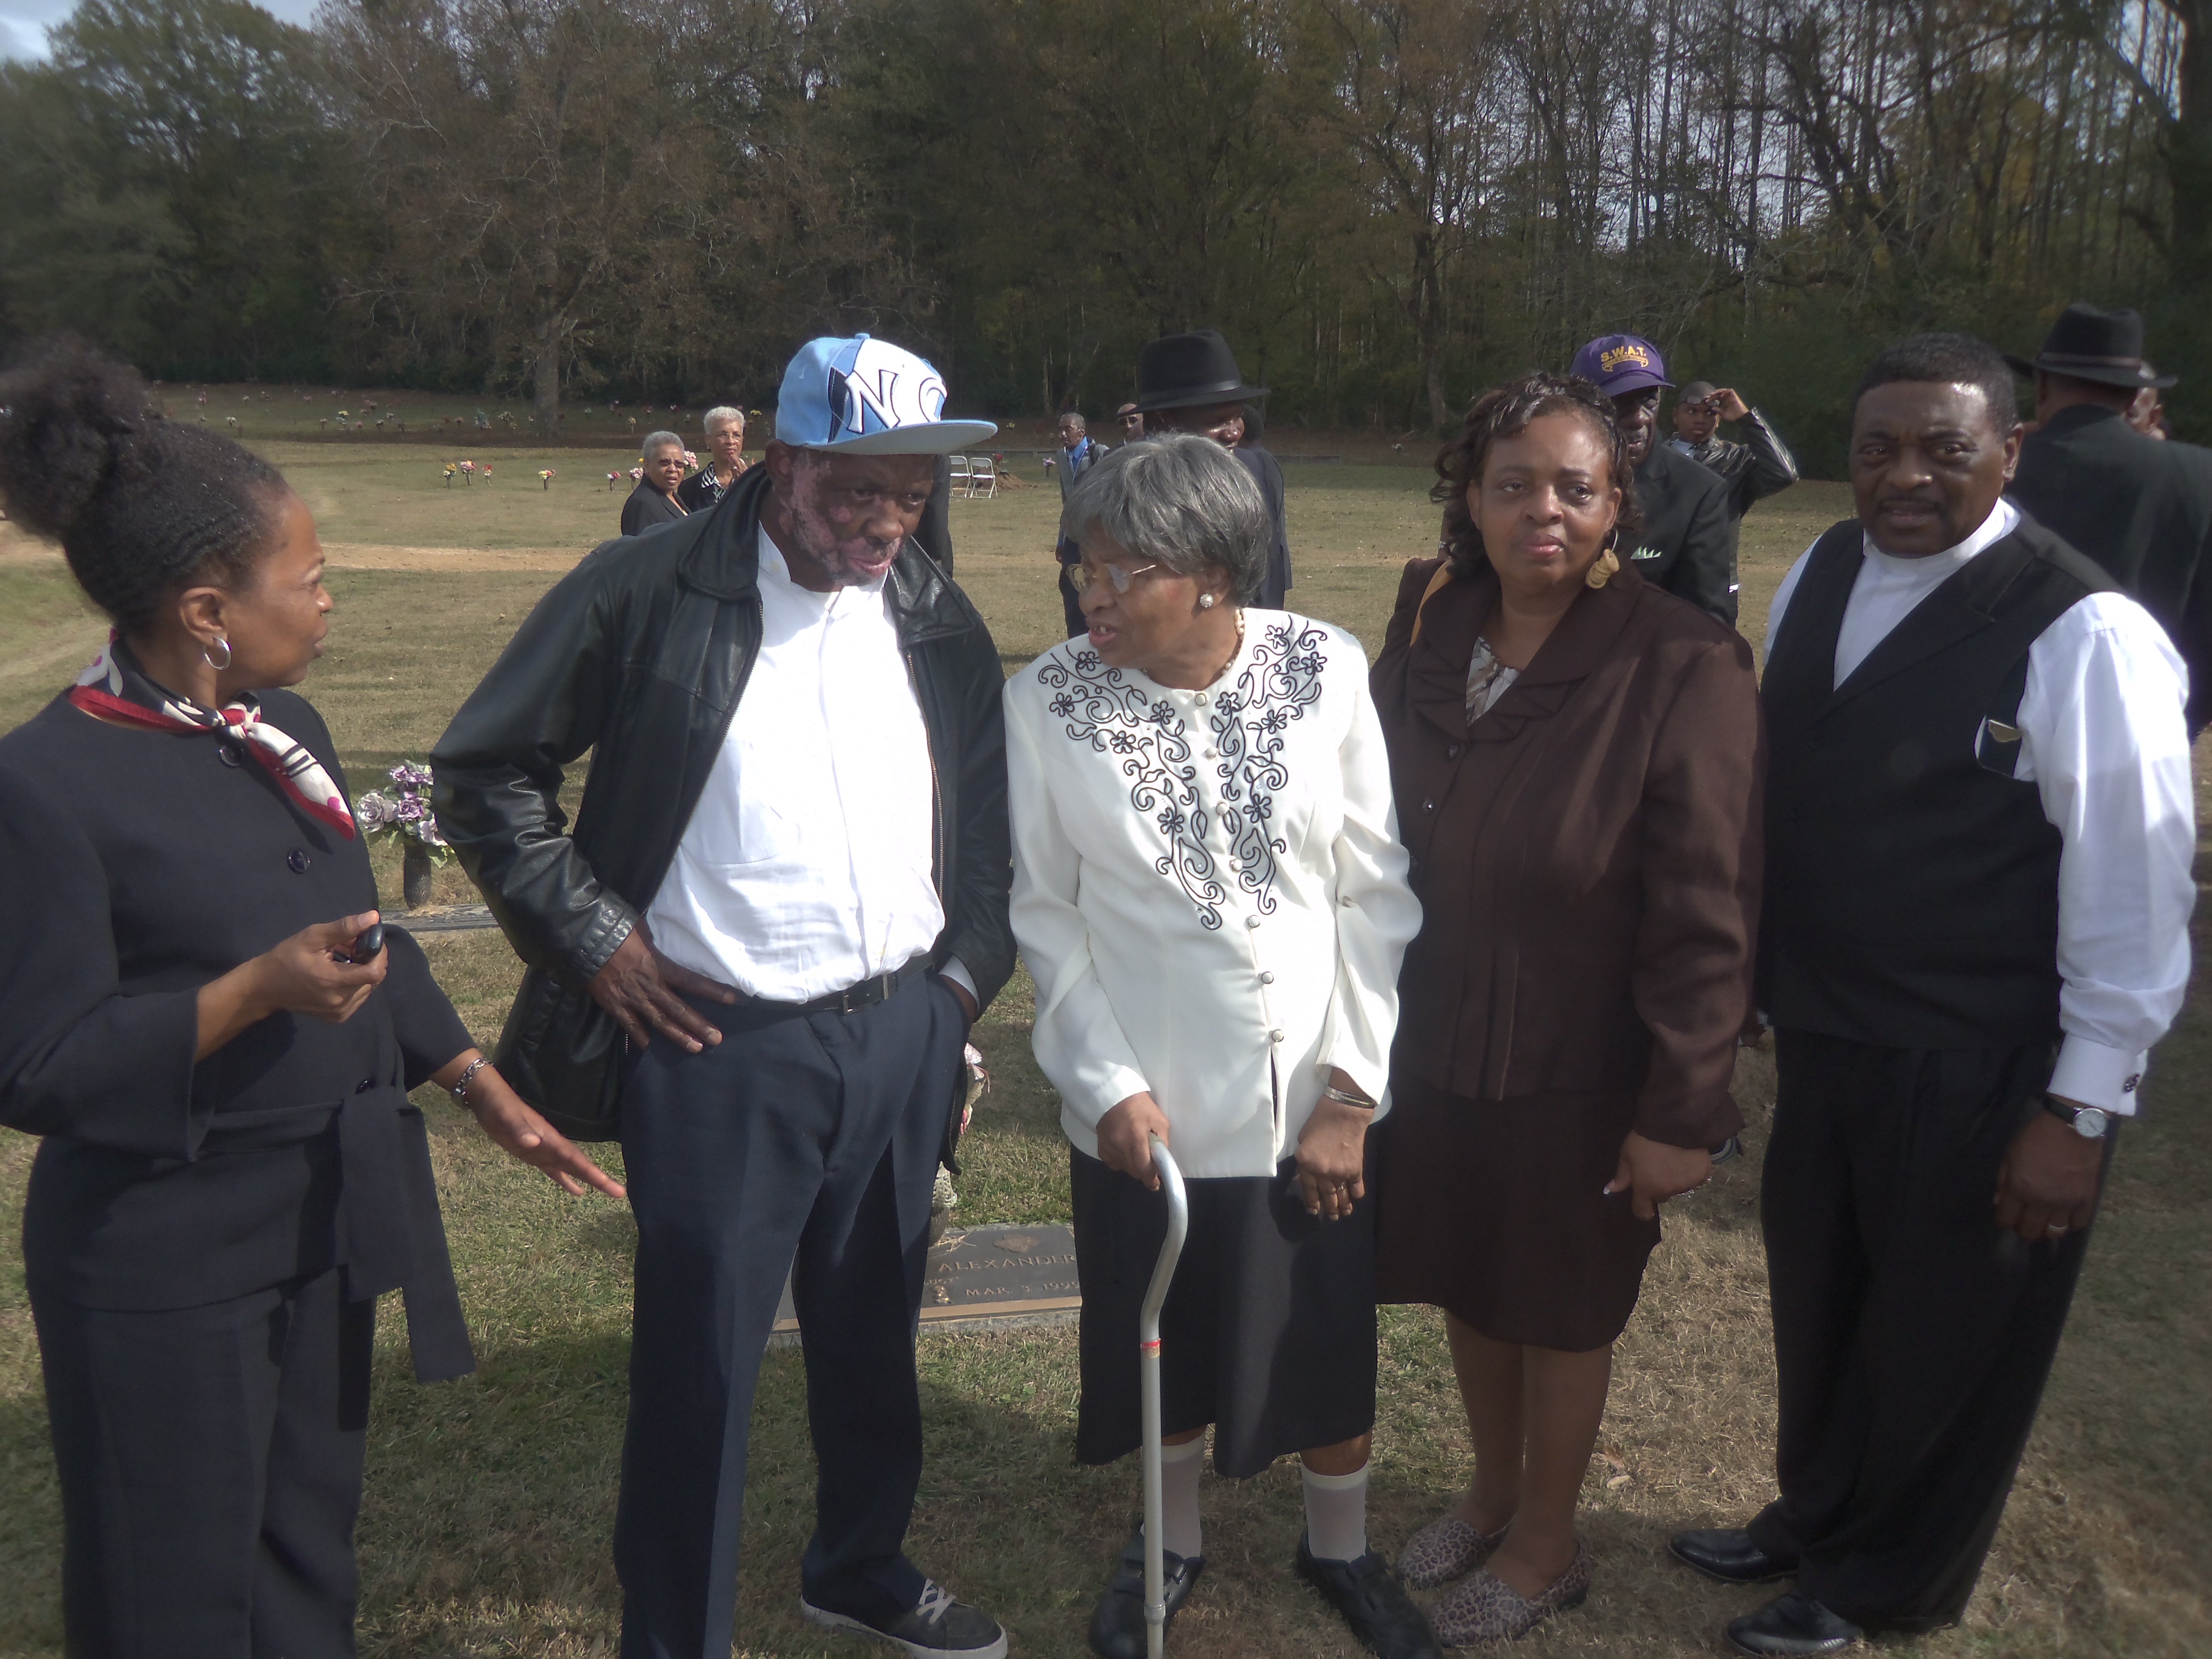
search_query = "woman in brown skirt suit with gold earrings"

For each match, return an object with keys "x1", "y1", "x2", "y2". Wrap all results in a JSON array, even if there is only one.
[{"x1": 1374, "y1": 376, "x2": 1765, "y2": 1646}]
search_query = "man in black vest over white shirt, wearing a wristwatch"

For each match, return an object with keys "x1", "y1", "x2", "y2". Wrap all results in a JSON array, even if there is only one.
[{"x1": 1672, "y1": 334, "x2": 2197, "y2": 1654}]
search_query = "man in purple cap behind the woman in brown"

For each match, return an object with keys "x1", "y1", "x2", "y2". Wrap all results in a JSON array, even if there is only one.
[{"x1": 1568, "y1": 334, "x2": 1736, "y2": 628}]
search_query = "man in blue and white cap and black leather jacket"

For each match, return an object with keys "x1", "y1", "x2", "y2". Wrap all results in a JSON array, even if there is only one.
[{"x1": 431, "y1": 334, "x2": 1013, "y2": 1659}]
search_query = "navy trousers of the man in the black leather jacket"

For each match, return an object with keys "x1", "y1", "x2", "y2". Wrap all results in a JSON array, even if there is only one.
[{"x1": 615, "y1": 975, "x2": 967, "y2": 1659}]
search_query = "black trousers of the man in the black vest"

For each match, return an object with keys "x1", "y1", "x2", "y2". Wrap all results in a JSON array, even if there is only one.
[{"x1": 1752, "y1": 1031, "x2": 2110, "y2": 1630}]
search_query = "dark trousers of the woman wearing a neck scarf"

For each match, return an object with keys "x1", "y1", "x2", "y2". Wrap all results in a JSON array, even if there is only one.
[{"x1": 31, "y1": 1272, "x2": 376, "y2": 1659}]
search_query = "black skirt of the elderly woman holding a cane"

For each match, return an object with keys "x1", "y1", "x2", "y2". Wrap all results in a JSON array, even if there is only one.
[{"x1": 1068, "y1": 1152, "x2": 1376, "y2": 1477}]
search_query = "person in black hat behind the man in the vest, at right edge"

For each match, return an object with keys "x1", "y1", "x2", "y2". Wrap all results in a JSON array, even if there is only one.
[{"x1": 2006, "y1": 303, "x2": 2212, "y2": 737}]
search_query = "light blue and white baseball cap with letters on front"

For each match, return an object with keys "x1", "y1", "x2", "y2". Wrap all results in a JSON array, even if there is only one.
[{"x1": 776, "y1": 334, "x2": 998, "y2": 456}]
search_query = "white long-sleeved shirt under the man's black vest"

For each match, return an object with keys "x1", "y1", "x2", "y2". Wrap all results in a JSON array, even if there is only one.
[{"x1": 1767, "y1": 500, "x2": 2197, "y2": 1113}]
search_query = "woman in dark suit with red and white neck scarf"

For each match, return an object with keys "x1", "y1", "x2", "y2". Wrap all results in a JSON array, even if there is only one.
[{"x1": 0, "y1": 345, "x2": 622, "y2": 1659}]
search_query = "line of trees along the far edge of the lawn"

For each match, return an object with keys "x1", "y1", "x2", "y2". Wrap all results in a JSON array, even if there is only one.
[{"x1": 0, "y1": 0, "x2": 2212, "y2": 464}]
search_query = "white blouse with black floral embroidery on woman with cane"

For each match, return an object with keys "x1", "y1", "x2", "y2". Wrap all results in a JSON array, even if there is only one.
[{"x1": 1006, "y1": 608, "x2": 1420, "y2": 1177}]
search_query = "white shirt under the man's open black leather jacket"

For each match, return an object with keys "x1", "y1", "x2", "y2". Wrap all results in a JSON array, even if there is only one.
[{"x1": 646, "y1": 529, "x2": 955, "y2": 1002}]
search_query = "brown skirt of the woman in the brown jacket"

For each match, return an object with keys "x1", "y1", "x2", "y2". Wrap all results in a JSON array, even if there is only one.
[{"x1": 1369, "y1": 1077, "x2": 1659, "y2": 1354}]
